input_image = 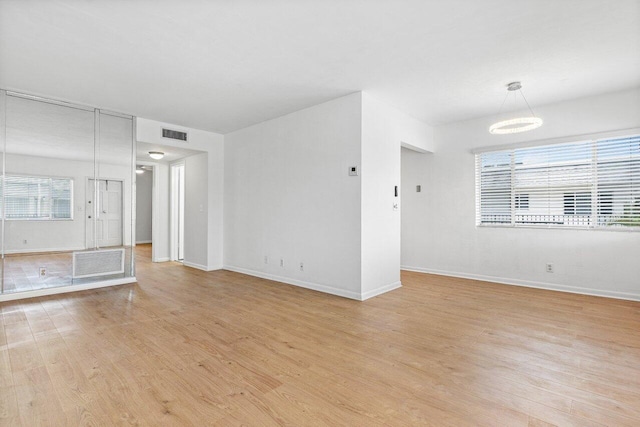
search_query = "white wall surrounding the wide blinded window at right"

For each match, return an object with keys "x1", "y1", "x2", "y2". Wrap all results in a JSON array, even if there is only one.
[{"x1": 402, "y1": 90, "x2": 640, "y2": 299}]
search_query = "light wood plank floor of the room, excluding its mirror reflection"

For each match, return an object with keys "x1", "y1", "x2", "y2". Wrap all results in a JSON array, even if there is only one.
[{"x1": 0, "y1": 242, "x2": 640, "y2": 426}]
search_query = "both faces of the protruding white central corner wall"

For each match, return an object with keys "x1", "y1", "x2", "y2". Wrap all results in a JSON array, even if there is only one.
[{"x1": 224, "y1": 93, "x2": 433, "y2": 299}]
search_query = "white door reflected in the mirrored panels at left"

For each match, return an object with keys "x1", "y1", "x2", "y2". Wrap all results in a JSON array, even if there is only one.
[{"x1": 86, "y1": 178, "x2": 123, "y2": 248}]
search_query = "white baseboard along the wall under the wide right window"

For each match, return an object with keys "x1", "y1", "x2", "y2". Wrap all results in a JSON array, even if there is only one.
[{"x1": 400, "y1": 265, "x2": 640, "y2": 301}]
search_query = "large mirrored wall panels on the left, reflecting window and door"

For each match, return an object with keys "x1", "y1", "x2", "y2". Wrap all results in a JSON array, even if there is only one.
[{"x1": 0, "y1": 91, "x2": 135, "y2": 293}]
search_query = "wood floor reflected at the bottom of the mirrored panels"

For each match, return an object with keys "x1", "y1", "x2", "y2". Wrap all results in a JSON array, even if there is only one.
[{"x1": 2, "y1": 247, "x2": 131, "y2": 293}]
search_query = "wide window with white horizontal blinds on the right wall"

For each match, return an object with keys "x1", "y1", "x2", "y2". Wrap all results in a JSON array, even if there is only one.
[{"x1": 476, "y1": 135, "x2": 640, "y2": 229}]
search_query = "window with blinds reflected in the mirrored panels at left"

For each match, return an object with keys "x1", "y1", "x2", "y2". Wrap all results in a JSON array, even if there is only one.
[{"x1": 0, "y1": 175, "x2": 73, "y2": 220}]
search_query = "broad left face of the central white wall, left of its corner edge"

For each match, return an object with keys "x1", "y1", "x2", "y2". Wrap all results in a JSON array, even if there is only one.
[{"x1": 224, "y1": 93, "x2": 361, "y2": 299}]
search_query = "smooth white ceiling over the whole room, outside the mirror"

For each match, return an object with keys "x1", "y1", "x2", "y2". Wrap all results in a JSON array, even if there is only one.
[{"x1": 0, "y1": 0, "x2": 640, "y2": 133}]
